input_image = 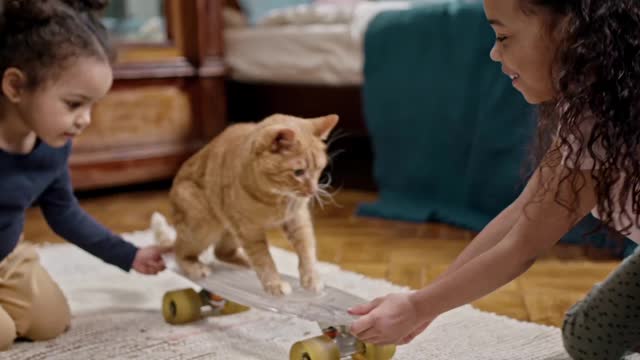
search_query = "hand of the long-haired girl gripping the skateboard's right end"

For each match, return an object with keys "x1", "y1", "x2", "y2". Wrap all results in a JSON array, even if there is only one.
[{"x1": 349, "y1": 293, "x2": 431, "y2": 345}]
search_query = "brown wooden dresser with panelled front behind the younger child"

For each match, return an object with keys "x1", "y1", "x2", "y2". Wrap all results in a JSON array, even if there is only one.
[{"x1": 70, "y1": 0, "x2": 226, "y2": 190}]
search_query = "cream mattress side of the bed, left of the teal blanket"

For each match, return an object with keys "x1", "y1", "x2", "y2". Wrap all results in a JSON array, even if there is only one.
[{"x1": 225, "y1": 24, "x2": 362, "y2": 86}]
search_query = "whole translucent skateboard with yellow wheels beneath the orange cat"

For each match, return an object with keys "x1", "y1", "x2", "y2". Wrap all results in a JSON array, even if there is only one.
[{"x1": 162, "y1": 255, "x2": 395, "y2": 360}]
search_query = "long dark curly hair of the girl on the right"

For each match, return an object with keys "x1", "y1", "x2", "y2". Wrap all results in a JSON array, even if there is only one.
[{"x1": 520, "y1": 0, "x2": 640, "y2": 234}]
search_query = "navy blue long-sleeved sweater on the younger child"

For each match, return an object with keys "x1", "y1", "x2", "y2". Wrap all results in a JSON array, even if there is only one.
[{"x1": 0, "y1": 141, "x2": 137, "y2": 271}]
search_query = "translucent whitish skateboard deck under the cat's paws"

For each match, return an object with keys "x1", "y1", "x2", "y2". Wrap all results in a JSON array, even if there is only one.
[{"x1": 165, "y1": 255, "x2": 367, "y2": 327}]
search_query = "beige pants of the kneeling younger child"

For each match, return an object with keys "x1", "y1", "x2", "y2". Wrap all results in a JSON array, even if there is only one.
[{"x1": 0, "y1": 239, "x2": 71, "y2": 350}]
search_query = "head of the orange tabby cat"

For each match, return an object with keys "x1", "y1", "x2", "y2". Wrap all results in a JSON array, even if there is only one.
[{"x1": 254, "y1": 115, "x2": 338, "y2": 197}]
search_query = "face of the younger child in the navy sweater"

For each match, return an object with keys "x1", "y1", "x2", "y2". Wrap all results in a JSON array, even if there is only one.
[{"x1": 17, "y1": 57, "x2": 113, "y2": 147}]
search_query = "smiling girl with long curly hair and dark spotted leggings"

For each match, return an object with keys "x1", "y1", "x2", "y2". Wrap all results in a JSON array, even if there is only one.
[{"x1": 351, "y1": 0, "x2": 640, "y2": 360}]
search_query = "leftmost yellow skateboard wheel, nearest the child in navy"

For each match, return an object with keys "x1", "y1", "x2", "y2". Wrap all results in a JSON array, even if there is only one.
[{"x1": 162, "y1": 288, "x2": 202, "y2": 325}]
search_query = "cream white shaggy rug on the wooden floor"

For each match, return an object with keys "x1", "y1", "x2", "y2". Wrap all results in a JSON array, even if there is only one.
[{"x1": 0, "y1": 231, "x2": 569, "y2": 360}]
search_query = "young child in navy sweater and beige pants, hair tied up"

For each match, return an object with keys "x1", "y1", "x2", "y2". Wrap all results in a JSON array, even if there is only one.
[{"x1": 0, "y1": 0, "x2": 167, "y2": 350}]
